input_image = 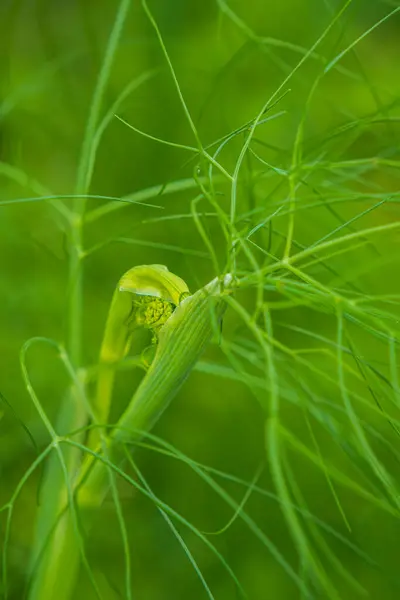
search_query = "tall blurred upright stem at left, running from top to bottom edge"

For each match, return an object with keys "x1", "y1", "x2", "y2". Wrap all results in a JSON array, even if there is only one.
[{"x1": 29, "y1": 0, "x2": 130, "y2": 600}]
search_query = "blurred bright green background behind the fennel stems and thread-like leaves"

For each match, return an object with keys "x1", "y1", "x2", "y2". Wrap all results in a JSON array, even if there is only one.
[{"x1": 0, "y1": 0, "x2": 400, "y2": 600}]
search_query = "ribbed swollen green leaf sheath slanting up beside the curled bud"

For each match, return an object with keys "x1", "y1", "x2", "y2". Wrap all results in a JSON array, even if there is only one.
[{"x1": 78, "y1": 277, "x2": 230, "y2": 506}]
